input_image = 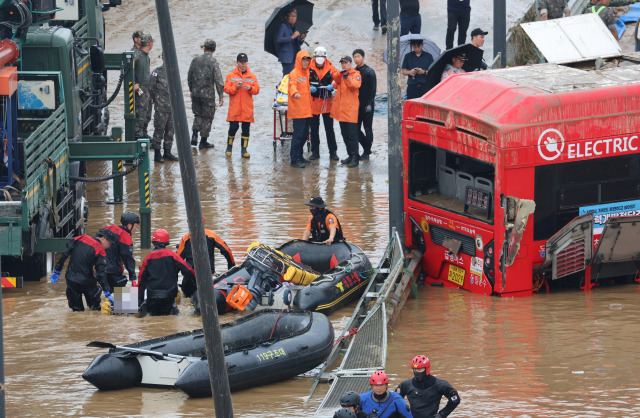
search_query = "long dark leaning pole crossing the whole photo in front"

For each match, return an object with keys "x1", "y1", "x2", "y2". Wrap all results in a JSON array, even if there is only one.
[{"x1": 156, "y1": 0, "x2": 233, "y2": 418}]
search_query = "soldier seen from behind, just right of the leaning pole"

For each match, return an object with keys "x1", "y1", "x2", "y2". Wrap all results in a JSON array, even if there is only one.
[{"x1": 188, "y1": 39, "x2": 224, "y2": 149}]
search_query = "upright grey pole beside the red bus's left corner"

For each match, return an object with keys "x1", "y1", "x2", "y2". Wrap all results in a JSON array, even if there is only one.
[{"x1": 387, "y1": 0, "x2": 404, "y2": 242}]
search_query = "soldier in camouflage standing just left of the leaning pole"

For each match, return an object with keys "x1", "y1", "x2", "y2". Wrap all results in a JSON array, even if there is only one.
[{"x1": 149, "y1": 56, "x2": 178, "y2": 163}]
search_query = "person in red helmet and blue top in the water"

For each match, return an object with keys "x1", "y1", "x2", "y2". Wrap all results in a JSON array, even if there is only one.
[{"x1": 360, "y1": 371, "x2": 412, "y2": 418}]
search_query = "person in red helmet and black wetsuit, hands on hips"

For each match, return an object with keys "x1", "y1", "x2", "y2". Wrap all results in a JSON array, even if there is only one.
[{"x1": 396, "y1": 355, "x2": 460, "y2": 418}]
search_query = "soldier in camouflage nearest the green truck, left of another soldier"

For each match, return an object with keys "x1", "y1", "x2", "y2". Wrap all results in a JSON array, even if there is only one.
[{"x1": 133, "y1": 34, "x2": 153, "y2": 139}]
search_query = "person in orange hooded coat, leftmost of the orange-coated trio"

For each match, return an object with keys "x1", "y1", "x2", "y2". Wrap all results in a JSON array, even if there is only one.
[{"x1": 287, "y1": 51, "x2": 313, "y2": 168}]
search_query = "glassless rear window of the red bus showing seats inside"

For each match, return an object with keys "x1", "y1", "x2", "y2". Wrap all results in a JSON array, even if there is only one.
[{"x1": 409, "y1": 141, "x2": 495, "y2": 224}]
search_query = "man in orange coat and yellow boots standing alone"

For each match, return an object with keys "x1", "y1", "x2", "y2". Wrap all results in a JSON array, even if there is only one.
[{"x1": 224, "y1": 54, "x2": 260, "y2": 158}]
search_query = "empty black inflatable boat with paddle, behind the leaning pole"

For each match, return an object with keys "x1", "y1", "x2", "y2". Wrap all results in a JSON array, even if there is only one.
[{"x1": 82, "y1": 309, "x2": 333, "y2": 396}]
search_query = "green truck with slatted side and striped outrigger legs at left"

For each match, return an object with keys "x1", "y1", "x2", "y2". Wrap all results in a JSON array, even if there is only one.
[{"x1": 0, "y1": 0, "x2": 151, "y2": 280}]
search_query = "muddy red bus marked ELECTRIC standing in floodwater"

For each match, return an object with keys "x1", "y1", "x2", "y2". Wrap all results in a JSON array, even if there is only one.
[{"x1": 402, "y1": 58, "x2": 640, "y2": 296}]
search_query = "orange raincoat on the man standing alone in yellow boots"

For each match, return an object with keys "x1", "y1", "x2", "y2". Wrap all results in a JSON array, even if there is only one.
[{"x1": 224, "y1": 66, "x2": 260, "y2": 122}]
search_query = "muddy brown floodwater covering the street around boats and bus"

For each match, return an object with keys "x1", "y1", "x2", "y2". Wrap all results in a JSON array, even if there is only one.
[{"x1": 3, "y1": 0, "x2": 640, "y2": 417}]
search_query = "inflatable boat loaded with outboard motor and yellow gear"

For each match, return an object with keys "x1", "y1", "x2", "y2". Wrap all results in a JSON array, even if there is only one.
[{"x1": 214, "y1": 240, "x2": 373, "y2": 315}]
